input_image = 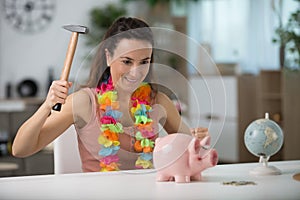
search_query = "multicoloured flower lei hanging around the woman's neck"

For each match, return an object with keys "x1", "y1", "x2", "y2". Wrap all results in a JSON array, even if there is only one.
[{"x1": 96, "y1": 77, "x2": 155, "y2": 171}]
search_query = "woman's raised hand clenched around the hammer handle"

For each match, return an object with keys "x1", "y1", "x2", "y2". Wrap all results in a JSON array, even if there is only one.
[{"x1": 45, "y1": 80, "x2": 72, "y2": 109}]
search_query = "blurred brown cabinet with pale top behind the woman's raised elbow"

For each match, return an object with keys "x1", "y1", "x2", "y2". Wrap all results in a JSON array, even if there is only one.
[{"x1": 0, "y1": 98, "x2": 54, "y2": 177}]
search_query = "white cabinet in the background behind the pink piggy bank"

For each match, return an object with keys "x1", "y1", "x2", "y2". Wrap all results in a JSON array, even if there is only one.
[{"x1": 187, "y1": 76, "x2": 239, "y2": 163}]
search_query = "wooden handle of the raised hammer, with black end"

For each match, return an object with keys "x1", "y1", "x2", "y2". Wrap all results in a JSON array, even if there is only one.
[{"x1": 52, "y1": 32, "x2": 78, "y2": 111}]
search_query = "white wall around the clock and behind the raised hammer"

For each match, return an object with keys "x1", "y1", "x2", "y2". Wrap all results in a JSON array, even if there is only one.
[{"x1": 0, "y1": 0, "x2": 118, "y2": 98}]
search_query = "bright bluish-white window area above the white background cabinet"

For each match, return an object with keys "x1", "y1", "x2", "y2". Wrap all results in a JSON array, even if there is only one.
[{"x1": 187, "y1": 0, "x2": 299, "y2": 74}]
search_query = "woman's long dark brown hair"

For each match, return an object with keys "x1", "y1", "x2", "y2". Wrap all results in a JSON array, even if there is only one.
[{"x1": 86, "y1": 17, "x2": 154, "y2": 87}]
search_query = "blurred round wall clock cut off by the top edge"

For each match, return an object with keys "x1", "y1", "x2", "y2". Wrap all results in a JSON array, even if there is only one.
[{"x1": 3, "y1": 0, "x2": 55, "y2": 33}]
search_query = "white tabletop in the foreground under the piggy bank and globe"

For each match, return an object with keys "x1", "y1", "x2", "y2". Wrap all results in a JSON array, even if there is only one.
[{"x1": 0, "y1": 160, "x2": 300, "y2": 200}]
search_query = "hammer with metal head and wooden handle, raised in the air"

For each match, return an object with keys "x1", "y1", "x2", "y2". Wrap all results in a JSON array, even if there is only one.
[{"x1": 52, "y1": 25, "x2": 89, "y2": 111}]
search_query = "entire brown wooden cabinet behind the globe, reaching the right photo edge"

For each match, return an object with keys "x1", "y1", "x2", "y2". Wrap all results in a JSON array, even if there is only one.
[{"x1": 238, "y1": 70, "x2": 300, "y2": 162}]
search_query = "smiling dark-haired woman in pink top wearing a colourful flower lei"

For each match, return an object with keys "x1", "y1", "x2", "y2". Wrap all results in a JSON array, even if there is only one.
[{"x1": 12, "y1": 17, "x2": 207, "y2": 172}]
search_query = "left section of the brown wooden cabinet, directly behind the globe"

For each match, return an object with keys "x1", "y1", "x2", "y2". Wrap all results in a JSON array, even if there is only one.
[{"x1": 238, "y1": 70, "x2": 283, "y2": 162}]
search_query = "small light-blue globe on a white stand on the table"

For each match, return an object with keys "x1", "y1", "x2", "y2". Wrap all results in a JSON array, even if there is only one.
[{"x1": 244, "y1": 113, "x2": 284, "y2": 174}]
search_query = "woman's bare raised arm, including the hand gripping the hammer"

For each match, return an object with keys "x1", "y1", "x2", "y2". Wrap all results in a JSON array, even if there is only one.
[{"x1": 12, "y1": 81, "x2": 74, "y2": 157}]
